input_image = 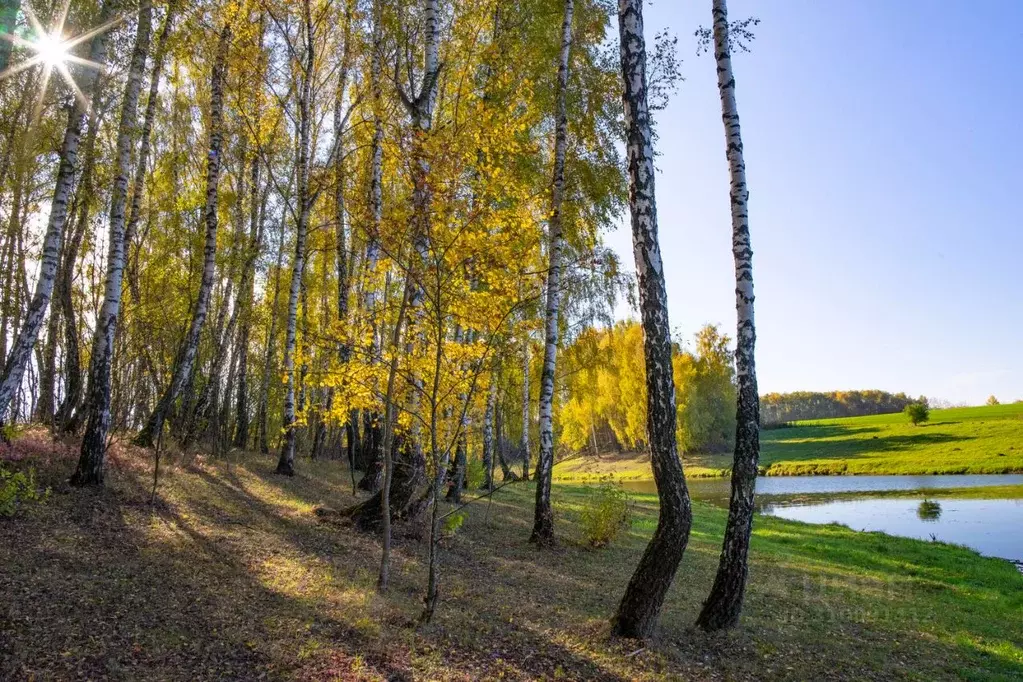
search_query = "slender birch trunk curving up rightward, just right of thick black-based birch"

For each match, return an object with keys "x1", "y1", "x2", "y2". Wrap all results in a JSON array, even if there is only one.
[{"x1": 135, "y1": 25, "x2": 231, "y2": 447}]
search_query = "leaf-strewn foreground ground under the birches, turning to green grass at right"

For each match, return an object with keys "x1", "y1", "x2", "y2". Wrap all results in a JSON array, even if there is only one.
[{"x1": 0, "y1": 431, "x2": 1023, "y2": 680}]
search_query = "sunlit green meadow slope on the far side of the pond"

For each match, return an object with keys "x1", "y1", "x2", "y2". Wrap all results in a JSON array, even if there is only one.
[{"x1": 554, "y1": 404, "x2": 1023, "y2": 482}]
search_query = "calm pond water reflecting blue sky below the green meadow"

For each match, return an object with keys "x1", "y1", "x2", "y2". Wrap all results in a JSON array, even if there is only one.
[{"x1": 624, "y1": 474, "x2": 1023, "y2": 560}]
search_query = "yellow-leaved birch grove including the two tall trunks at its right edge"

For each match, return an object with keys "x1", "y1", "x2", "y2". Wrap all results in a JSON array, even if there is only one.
[{"x1": 0, "y1": 0, "x2": 759, "y2": 638}]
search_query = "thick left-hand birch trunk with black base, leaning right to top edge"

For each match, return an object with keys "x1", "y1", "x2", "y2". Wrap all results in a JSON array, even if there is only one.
[{"x1": 71, "y1": 0, "x2": 152, "y2": 486}]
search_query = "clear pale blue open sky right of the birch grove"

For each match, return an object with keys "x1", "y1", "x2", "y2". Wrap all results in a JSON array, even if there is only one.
[{"x1": 608, "y1": 0, "x2": 1023, "y2": 404}]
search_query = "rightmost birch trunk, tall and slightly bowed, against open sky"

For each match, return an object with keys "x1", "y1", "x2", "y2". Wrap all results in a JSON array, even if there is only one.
[{"x1": 697, "y1": 0, "x2": 760, "y2": 630}]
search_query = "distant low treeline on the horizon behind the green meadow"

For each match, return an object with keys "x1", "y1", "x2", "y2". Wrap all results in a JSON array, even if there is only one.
[{"x1": 760, "y1": 391, "x2": 926, "y2": 426}]
